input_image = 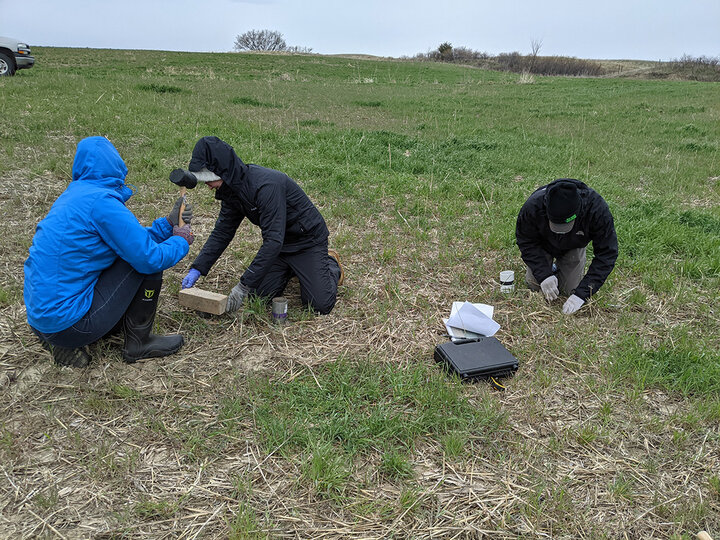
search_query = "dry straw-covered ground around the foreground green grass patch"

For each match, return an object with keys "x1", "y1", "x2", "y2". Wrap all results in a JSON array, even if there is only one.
[{"x1": 0, "y1": 167, "x2": 720, "y2": 539}]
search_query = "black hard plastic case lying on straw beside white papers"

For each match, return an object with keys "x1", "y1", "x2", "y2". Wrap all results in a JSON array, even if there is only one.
[{"x1": 435, "y1": 337, "x2": 518, "y2": 380}]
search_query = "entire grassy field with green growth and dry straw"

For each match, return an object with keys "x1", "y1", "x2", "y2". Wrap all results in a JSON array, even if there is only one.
[{"x1": 0, "y1": 48, "x2": 720, "y2": 539}]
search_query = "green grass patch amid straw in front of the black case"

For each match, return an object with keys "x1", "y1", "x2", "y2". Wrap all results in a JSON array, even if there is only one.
[{"x1": 219, "y1": 360, "x2": 506, "y2": 496}]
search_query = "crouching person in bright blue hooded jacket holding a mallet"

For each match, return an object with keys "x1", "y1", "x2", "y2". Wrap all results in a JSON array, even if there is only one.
[{"x1": 23, "y1": 137, "x2": 193, "y2": 367}]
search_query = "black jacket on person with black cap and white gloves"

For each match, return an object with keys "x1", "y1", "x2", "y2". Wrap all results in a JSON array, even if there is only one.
[{"x1": 515, "y1": 178, "x2": 618, "y2": 300}]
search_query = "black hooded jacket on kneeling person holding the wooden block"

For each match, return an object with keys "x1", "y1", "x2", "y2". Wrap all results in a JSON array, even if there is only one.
[{"x1": 189, "y1": 137, "x2": 328, "y2": 289}]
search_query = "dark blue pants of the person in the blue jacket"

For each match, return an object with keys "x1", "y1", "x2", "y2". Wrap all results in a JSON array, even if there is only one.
[{"x1": 33, "y1": 258, "x2": 162, "y2": 349}]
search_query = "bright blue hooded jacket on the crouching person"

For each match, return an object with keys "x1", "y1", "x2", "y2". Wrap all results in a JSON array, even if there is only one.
[{"x1": 23, "y1": 137, "x2": 189, "y2": 334}]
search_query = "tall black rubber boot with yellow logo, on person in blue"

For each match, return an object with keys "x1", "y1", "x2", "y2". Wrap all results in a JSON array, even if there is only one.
[{"x1": 123, "y1": 279, "x2": 184, "y2": 364}]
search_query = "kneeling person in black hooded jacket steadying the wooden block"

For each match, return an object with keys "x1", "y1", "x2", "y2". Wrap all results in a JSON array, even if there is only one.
[{"x1": 170, "y1": 137, "x2": 344, "y2": 314}]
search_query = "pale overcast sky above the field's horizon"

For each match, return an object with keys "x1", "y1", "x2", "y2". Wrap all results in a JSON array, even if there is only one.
[{"x1": 0, "y1": 0, "x2": 720, "y2": 60}]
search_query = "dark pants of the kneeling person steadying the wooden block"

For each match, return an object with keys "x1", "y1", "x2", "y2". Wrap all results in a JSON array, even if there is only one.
[{"x1": 254, "y1": 242, "x2": 340, "y2": 315}]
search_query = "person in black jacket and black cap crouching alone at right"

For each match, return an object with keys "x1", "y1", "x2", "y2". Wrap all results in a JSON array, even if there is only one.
[{"x1": 515, "y1": 178, "x2": 618, "y2": 314}]
